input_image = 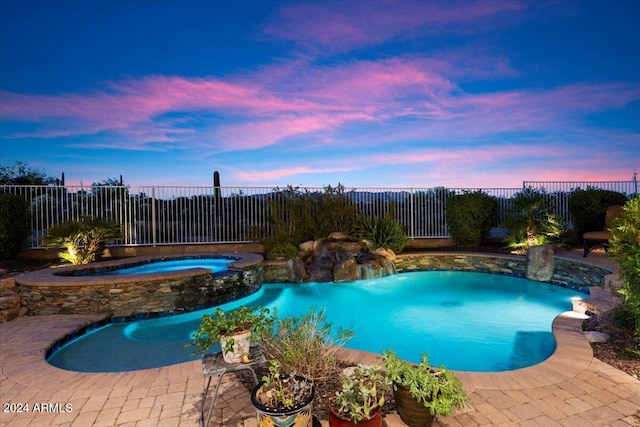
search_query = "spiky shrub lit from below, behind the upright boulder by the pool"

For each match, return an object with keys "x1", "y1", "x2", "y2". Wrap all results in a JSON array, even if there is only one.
[{"x1": 501, "y1": 188, "x2": 567, "y2": 251}]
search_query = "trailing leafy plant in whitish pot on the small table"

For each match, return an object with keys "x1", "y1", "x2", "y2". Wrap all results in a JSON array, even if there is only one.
[{"x1": 188, "y1": 306, "x2": 273, "y2": 363}]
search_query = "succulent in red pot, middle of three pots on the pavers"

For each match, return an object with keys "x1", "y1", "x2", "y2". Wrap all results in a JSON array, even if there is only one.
[{"x1": 329, "y1": 365, "x2": 389, "y2": 427}]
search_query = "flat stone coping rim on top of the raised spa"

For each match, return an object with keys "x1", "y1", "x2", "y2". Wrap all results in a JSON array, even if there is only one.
[{"x1": 16, "y1": 252, "x2": 263, "y2": 287}]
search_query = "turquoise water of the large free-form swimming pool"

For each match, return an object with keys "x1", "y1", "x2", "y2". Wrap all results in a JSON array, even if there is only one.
[{"x1": 48, "y1": 271, "x2": 585, "y2": 372}]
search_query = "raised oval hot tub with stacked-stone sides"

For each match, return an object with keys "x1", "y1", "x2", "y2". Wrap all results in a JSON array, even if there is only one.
[{"x1": 16, "y1": 252, "x2": 264, "y2": 317}]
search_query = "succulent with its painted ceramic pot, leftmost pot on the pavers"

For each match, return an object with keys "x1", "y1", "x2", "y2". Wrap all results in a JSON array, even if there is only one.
[{"x1": 251, "y1": 360, "x2": 316, "y2": 427}]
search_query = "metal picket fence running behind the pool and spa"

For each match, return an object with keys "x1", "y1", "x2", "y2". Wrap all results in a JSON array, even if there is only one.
[{"x1": 0, "y1": 181, "x2": 637, "y2": 248}]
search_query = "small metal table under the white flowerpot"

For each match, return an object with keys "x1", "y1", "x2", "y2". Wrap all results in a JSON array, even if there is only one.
[{"x1": 200, "y1": 346, "x2": 266, "y2": 426}]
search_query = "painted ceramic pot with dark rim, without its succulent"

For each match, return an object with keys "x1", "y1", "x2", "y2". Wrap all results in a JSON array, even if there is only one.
[{"x1": 251, "y1": 382, "x2": 316, "y2": 427}]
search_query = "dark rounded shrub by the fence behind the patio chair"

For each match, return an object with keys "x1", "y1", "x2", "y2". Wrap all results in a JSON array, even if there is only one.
[{"x1": 569, "y1": 187, "x2": 627, "y2": 238}]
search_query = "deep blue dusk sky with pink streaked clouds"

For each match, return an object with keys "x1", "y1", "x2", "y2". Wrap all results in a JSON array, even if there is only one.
[{"x1": 0, "y1": 0, "x2": 640, "y2": 188}]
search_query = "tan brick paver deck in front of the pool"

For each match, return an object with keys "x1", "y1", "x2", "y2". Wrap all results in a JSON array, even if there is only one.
[{"x1": 0, "y1": 251, "x2": 640, "y2": 427}]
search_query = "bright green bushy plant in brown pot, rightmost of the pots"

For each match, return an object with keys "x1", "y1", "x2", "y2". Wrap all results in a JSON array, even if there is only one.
[{"x1": 384, "y1": 350, "x2": 467, "y2": 427}]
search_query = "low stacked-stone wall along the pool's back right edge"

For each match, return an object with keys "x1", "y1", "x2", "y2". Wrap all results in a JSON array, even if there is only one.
[{"x1": 395, "y1": 253, "x2": 611, "y2": 293}]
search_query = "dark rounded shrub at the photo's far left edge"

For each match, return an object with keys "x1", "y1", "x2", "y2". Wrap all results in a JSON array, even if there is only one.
[{"x1": 0, "y1": 194, "x2": 31, "y2": 259}]
